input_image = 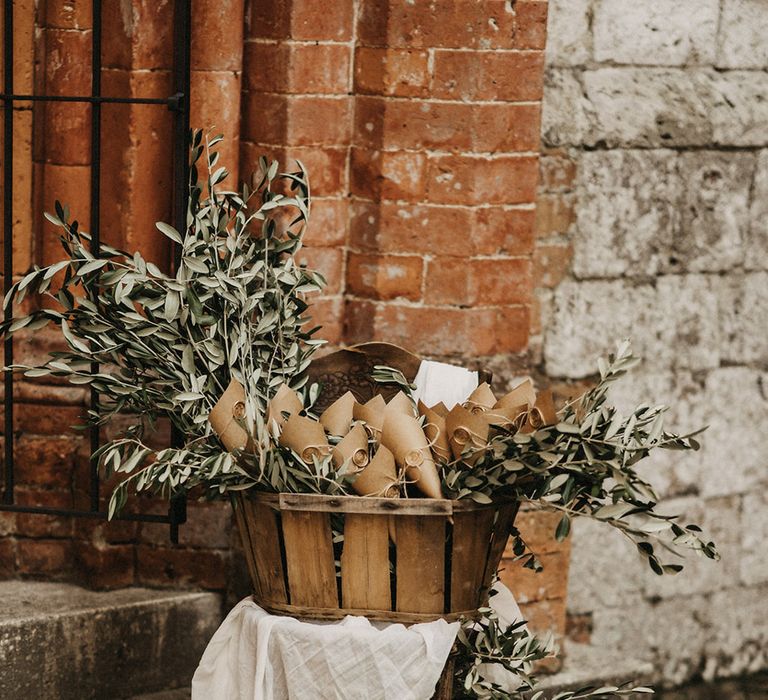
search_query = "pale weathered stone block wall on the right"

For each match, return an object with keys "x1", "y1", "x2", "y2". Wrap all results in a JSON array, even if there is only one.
[{"x1": 531, "y1": 0, "x2": 768, "y2": 682}]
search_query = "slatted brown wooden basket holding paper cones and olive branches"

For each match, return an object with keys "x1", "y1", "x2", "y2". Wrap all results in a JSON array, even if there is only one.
[{"x1": 233, "y1": 491, "x2": 518, "y2": 624}]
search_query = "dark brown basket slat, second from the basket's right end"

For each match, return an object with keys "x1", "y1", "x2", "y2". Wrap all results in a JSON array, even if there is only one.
[{"x1": 451, "y1": 510, "x2": 494, "y2": 610}]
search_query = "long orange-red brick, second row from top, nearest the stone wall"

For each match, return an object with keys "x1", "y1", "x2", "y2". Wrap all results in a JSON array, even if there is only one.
[{"x1": 432, "y1": 51, "x2": 544, "y2": 102}]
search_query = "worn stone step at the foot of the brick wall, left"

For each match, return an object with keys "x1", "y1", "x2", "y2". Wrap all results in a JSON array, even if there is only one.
[{"x1": 0, "y1": 581, "x2": 221, "y2": 700}]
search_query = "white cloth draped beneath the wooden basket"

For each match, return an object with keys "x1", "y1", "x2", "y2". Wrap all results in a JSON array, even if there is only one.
[{"x1": 192, "y1": 598, "x2": 459, "y2": 700}]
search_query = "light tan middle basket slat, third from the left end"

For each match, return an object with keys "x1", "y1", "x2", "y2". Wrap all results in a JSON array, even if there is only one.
[{"x1": 341, "y1": 514, "x2": 392, "y2": 610}]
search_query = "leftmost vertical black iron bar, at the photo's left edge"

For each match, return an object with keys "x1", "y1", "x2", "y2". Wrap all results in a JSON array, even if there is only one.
[{"x1": 3, "y1": 2, "x2": 14, "y2": 504}]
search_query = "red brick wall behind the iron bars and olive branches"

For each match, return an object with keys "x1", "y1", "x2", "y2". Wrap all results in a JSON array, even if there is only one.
[{"x1": 0, "y1": 0, "x2": 559, "y2": 612}]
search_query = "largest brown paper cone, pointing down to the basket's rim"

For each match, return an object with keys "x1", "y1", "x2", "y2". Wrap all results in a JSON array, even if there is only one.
[{"x1": 381, "y1": 411, "x2": 443, "y2": 498}]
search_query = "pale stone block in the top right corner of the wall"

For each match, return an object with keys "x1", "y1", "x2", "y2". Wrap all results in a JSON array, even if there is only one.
[{"x1": 717, "y1": 0, "x2": 768, "y2": 68}]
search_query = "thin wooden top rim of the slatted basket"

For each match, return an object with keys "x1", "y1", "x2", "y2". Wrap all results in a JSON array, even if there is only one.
[{"x1": 237, "y1": 489, "x2": 518, "y2": 517}]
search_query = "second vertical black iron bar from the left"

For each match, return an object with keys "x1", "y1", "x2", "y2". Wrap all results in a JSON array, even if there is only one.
[{"x1": 88, "y1": 0, "x2": 101, "y2": 511}]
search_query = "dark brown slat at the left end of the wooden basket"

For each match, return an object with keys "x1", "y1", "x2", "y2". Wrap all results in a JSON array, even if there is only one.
[{"x1": 239, "y1": 498, "x2": 288, "y2": 603}]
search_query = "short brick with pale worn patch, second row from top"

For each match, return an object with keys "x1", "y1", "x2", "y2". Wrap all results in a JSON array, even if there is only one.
[{"x1": 355, "y1": 46, "x2": 430, "y2": 97}]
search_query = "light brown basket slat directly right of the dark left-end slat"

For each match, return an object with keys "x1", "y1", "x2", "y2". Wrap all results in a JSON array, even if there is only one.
[{"x1": 282, "y1": 511, "x2": 339, "y2": 608}]
